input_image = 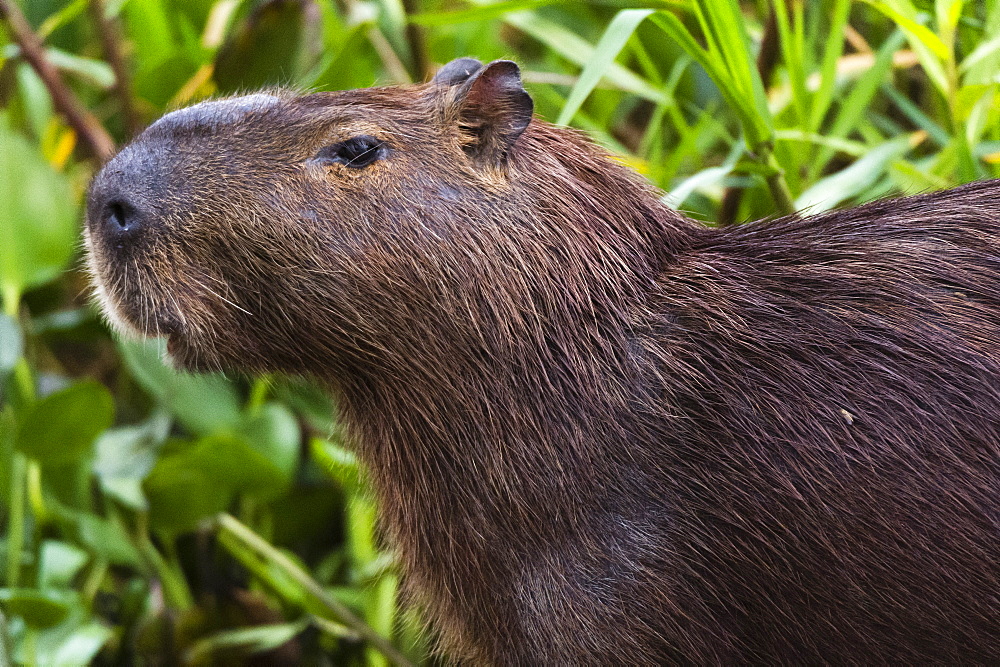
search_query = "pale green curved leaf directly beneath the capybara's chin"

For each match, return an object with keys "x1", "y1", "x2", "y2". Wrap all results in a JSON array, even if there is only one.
[{"x1": 119, "y1": 340, "x2": 243, "y2": 434}]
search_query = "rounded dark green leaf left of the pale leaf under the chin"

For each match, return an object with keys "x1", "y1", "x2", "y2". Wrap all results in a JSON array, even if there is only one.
[{"x1": 16, "y1": 382, "x2": 114, "y2": 465}]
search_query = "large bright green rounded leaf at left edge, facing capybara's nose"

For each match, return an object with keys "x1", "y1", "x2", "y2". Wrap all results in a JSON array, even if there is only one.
[{"x1": 0, "y1": 114, "x2": 77, "y2": 310}]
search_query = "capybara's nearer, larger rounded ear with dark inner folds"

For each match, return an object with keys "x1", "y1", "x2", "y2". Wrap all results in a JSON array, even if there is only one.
[{"x1": 448, "y1": 60, "x2": 535, "y2": 166}]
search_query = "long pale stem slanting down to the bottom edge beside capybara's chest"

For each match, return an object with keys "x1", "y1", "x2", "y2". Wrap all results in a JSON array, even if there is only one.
[{"x1": 217, "y1": 514, "x2": 412, "y2": 666}]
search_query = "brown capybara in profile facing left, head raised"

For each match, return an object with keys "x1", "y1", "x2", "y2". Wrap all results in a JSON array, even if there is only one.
[{"x1": 86, "y1": 59, "x2": 1000, "y2": 665}]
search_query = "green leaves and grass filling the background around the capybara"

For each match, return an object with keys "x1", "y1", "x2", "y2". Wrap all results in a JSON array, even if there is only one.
[{"x1": 0, "y1": 0, "x2": 1000, "y2": 665}]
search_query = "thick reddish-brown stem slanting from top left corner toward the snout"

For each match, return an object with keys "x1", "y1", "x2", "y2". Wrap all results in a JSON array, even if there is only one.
[{"x1": 0, "y1": 0, "x2": 115, "y2": 160}]
